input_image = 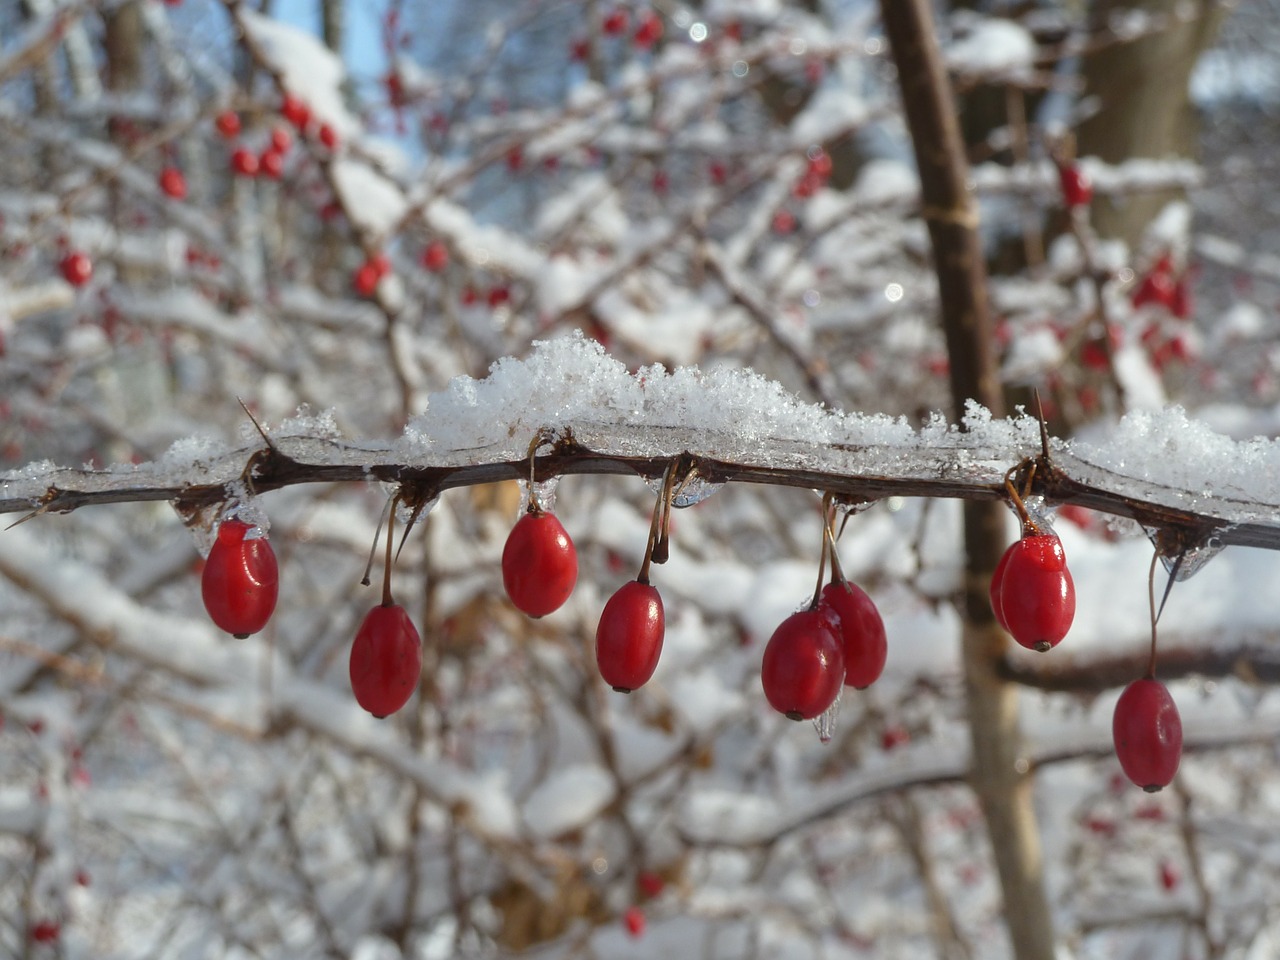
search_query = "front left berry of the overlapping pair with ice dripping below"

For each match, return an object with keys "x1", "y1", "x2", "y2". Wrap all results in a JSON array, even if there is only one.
[{"x1": 760, "y1": 609, "x2": 845, "y2": 719}]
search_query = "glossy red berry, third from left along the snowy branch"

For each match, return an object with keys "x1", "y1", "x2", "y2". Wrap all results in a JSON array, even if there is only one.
[{"x1": 502, "y1": 509, "x2": 577, "y2": 617}]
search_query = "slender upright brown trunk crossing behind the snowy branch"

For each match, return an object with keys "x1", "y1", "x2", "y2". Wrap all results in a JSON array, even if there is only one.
[{"x1": 881, "y1": 0, "x2": 1053, "y2": 960}]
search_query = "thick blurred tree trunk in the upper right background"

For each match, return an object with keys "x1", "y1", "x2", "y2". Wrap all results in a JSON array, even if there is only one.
[{"x1": 1076, "y1": 0, "x2": 1226, "y2": 248}]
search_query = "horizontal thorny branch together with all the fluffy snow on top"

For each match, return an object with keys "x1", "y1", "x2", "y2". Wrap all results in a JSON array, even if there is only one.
[{"x1": 0, "y1": 335, "x2": 1280, "y2": 549}]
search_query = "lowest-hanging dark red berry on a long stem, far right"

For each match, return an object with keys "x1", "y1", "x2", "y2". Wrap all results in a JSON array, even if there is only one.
[{"x1": 1111, "y1": 677, "x2": 1183, "y2": 794}]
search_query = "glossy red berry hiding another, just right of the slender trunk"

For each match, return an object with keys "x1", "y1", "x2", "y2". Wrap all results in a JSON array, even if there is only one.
[{"x1": 991, "y1": 534, "x2": 1075, "y2": 653}]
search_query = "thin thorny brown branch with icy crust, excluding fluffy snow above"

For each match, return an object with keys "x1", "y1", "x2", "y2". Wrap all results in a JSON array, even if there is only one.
[{"x1": 0, "y1": 424, "x2": 1280, "y2": 547}]
